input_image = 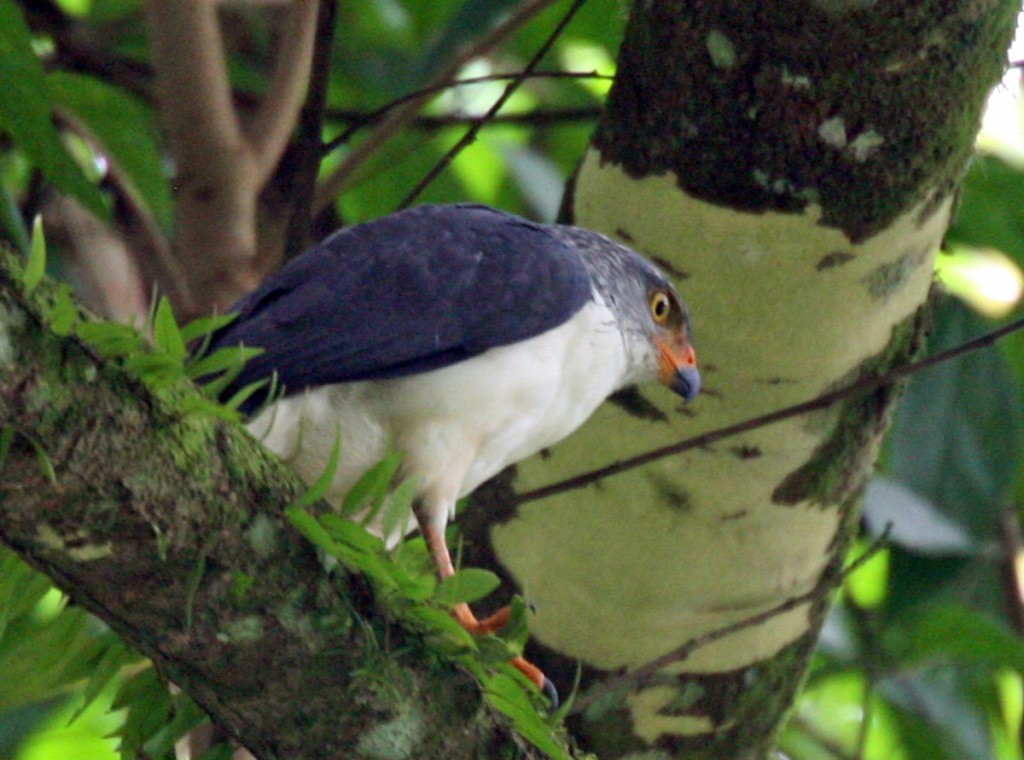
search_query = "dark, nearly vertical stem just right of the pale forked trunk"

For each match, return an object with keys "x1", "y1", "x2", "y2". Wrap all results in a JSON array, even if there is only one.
[{"x1": 285, "y1": 0, "x2": 338, "y2": 260}]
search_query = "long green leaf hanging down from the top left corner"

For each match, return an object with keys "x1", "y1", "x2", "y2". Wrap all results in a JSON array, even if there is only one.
[{"x1": 0, "y1": 0, "x2": 109, "y2": 219}]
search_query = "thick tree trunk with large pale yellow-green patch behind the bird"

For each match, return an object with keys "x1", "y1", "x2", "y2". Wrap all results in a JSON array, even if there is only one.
[{"x1": 464, "y1": 0, "x2": 1019, "y2": 758}]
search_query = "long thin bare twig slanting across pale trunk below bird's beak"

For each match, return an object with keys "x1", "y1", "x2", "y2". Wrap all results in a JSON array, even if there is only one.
[{"x1": 502, "y1": 319, "x2": 1024, "y2": 506}]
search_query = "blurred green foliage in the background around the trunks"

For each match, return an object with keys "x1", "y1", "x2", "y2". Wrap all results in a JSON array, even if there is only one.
[{"x1": 0, "y1": 0, "x2": 1024, "y2": 760}]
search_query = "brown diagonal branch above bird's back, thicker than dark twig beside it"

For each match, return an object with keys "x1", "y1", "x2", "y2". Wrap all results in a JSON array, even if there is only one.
[{"x1": 313, "y1": 0, "x2": 555, "y2": 214}]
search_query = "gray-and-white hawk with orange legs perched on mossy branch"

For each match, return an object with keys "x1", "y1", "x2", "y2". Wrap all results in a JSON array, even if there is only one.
[{"x1": 211, "y1": 204, "x2": 700, "y2": 700}]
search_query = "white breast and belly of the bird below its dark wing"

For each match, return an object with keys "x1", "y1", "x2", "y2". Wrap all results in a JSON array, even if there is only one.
[{"x1": 249, "y1": 301, "x2": 628, "y2": 540}]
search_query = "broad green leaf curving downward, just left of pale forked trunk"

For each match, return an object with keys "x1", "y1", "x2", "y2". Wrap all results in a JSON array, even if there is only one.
[{"x1": 47, "y1": 71, "x2": 174, "y2": 229}]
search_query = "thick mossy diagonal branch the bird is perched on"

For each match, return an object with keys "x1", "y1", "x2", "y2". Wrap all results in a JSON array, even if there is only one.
[{"x1": 0, "y1": 270, "x2": 536, "y2": 760}]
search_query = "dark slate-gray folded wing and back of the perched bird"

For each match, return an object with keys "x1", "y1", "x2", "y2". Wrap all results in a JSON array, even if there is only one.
[{"x1": 199, "y1": 204, "x2": 591, "y2": 412}]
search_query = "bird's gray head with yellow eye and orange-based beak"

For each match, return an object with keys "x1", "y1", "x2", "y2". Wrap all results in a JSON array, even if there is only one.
[{"x1": 552, "y1": 224, "x2": 700, "y2": 402}]
